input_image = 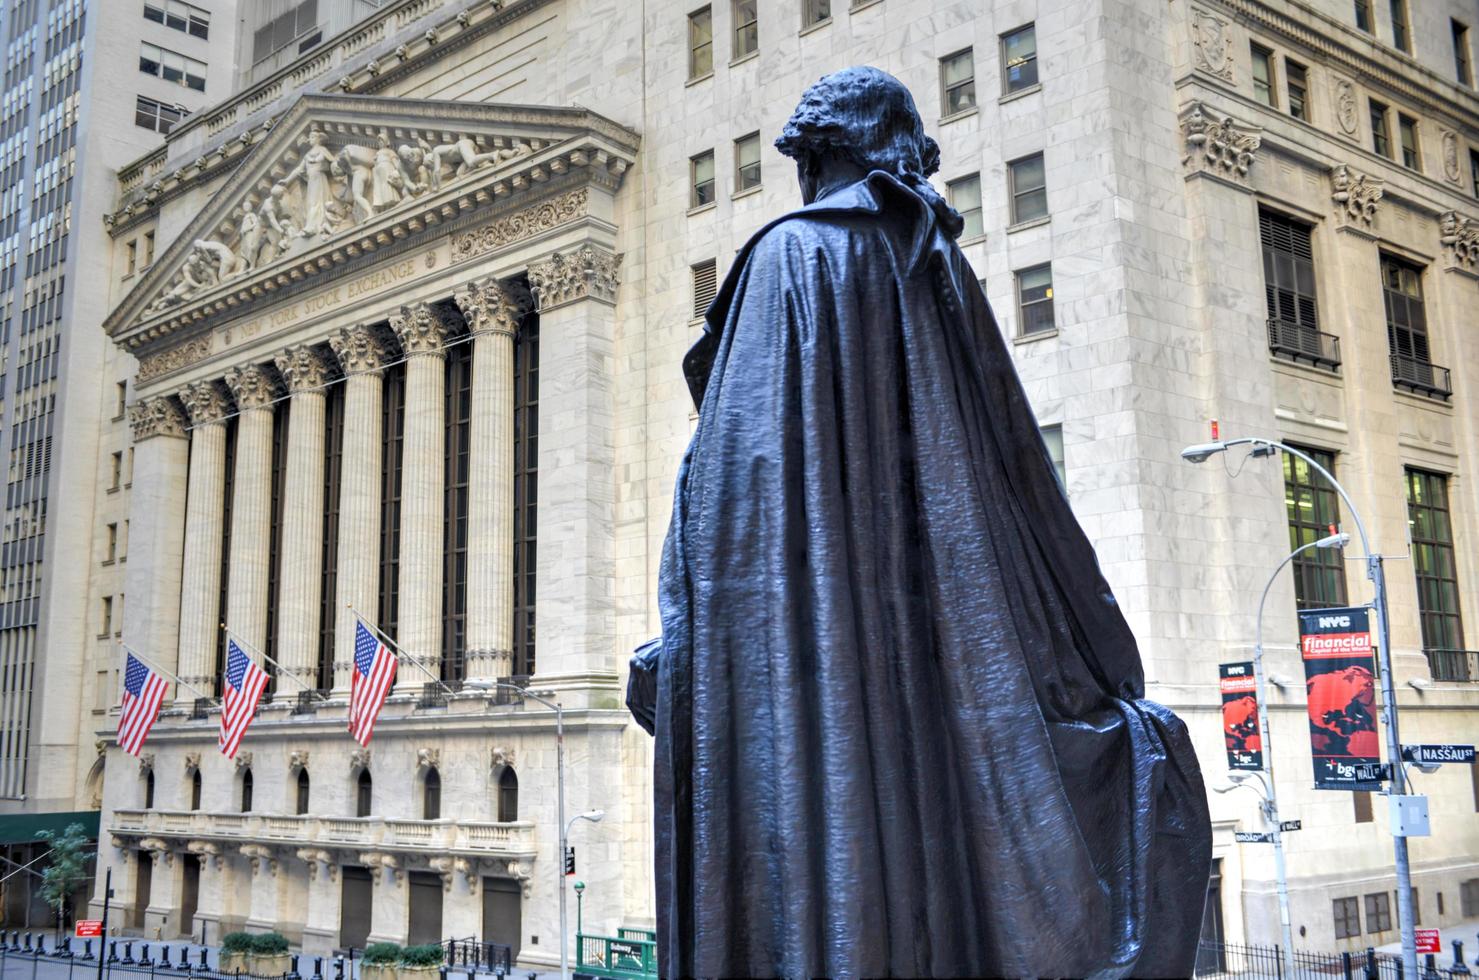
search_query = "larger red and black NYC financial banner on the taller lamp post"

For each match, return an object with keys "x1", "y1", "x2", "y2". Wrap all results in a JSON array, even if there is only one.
[{"x1": 1299, "y1": 606, "x2": 1381, "y2": 791}]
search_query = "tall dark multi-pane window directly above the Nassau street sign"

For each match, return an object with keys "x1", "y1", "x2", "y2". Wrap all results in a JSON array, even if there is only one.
[{"x1": 1407, "y1": 469, "x2": 1472, "y2": 680}]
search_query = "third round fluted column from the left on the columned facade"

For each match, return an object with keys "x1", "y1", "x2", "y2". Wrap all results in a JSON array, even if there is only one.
[{"x1": 275, "y1": 344, "x2": 328, "y2": 689}]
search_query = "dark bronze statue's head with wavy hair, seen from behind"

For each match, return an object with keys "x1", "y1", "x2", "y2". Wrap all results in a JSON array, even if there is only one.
[{"x1": 775, "y1": 65, "x2": 939, "y2": 201}]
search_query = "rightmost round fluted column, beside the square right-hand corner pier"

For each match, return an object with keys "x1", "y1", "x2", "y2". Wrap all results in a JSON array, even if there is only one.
[{"x1": 453, "y1": 276, "x2": 525, "y2": 678}]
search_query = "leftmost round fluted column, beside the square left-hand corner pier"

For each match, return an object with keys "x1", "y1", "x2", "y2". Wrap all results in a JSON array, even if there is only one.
[{"x1": 176, "y1": 381, "x2": 231, "y2": 701}]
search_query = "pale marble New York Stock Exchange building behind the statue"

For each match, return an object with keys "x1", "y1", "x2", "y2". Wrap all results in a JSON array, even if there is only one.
[{"x1": 58, "y1": 0, "x2": 1479, "y2": 965}]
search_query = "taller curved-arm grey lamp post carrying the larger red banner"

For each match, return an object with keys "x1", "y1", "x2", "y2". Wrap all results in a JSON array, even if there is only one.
[{"x1": 1182, "y1": 436, "x2": 1418, "y2": 977}]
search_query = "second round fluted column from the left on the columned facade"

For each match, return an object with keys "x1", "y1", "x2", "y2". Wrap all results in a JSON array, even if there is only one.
[{"x1": 226, "y1": 364, "x2": 277, "y2": 650}]
